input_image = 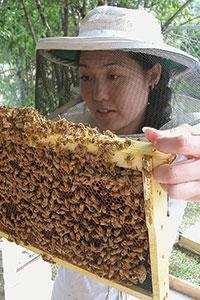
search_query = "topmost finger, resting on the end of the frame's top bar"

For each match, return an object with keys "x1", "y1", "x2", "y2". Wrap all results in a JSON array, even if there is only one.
[{"x1": 144, "y1": 125, "x2": 200, "y2": 157}]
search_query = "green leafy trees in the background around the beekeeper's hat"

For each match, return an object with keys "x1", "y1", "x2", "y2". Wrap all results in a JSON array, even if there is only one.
[{"x1": 0, "y1": 0, "x2": 200, "y2": 114}]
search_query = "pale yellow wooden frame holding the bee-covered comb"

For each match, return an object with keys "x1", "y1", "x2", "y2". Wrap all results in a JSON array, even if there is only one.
[{"x1": 0, "y1": 108, "x2": 171, "y2": 300}]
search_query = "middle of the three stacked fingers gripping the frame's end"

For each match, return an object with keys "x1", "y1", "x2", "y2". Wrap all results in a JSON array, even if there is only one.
[{"x1": 153, "y1": 159, "x2": 200, "y2": 184}]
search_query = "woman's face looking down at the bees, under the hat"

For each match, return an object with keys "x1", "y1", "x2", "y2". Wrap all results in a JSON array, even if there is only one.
[{"x1": 79, "y1": 51, "x2": 159, "y2": 134}]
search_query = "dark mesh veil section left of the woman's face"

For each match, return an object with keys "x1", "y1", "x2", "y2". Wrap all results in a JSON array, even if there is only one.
[{"x1": 35, "y1": 51, "x2": 79, "y2": 115}]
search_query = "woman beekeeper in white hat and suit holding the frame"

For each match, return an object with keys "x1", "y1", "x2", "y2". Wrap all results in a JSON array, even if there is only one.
[{"x1": 37, "y1": 6, "x2": 200, "y2": 300}]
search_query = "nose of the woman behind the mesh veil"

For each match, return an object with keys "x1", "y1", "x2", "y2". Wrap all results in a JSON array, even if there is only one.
[{"x1": 92, "y1": 77, "x2": 109, "y2": 101}]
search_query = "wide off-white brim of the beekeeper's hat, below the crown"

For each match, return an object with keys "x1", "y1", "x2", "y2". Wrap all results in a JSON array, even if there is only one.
[{"x1": 36, "y1": 37, "x2": 200, "y2": 71}]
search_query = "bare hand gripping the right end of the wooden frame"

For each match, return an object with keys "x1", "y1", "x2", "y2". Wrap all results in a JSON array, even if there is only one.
[{"x1": 143, "y1": 124, "x2": 200, "y2": 202}]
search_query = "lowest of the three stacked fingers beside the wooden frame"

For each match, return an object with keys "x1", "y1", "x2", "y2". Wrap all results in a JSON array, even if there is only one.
[{"x1": 161, "y1": 181, "x2": 200, "y2": 202}]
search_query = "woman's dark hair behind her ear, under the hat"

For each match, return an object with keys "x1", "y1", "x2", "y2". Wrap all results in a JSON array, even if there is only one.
[{"x1": 129, "y1": 52, "x2": 172, "y2": 133}]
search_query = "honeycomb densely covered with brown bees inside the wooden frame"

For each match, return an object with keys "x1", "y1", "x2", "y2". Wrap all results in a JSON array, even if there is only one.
[{"x1": 0, "y1": 108, "x2": 170, "y2": 286}]
